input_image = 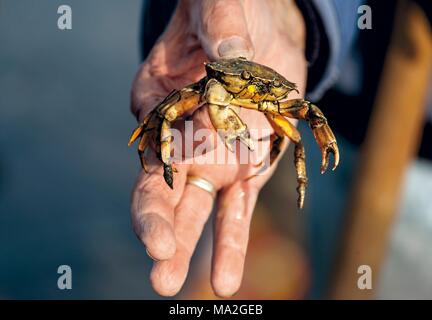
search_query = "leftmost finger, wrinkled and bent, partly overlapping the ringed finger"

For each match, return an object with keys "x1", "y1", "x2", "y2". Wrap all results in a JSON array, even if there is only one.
[{"x1": 131, "y1": 156, "x2": 186, "y2": 260}]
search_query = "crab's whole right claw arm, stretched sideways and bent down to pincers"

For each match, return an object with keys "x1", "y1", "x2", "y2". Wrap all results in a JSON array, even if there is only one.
[{"x1": 231, "y1": 99, "x2": 339, "y2": 173}]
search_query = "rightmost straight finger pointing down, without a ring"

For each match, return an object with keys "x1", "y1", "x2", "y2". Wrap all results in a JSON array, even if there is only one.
[{"x1": 211, "y1": 182, "x2": 259, "y2": 297}]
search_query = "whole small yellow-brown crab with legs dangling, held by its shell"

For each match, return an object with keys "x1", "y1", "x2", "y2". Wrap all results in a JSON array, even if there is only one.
[{"x1": 129, "y1": 58, "x2": 339, "y2": 208}]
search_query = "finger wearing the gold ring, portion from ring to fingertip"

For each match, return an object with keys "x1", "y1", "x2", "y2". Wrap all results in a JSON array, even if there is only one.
[{"x1": 150, "y1": 184, "x2": 213, "y2": 296}]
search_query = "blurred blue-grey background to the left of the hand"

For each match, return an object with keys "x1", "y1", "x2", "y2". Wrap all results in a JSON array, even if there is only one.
[{"x1": 0, "y1": 0, "x2": 161, "y2": 298}]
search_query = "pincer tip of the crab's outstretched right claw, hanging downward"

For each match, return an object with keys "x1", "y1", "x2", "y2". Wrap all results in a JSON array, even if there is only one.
[{"x1": 313, "y1": 123, "x2": 339, "y2": 174}]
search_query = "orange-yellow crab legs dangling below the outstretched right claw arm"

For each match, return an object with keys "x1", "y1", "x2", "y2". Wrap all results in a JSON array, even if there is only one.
[{"x1": 266, "y1": 113, "x2": 308, "y2": 209}]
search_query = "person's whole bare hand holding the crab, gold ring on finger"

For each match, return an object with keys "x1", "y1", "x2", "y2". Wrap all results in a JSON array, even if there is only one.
[{"x1": 131, "y1": 0, "x2": 307, "y2": 297}]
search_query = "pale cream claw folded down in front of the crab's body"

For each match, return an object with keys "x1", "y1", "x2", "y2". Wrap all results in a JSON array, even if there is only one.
[{"x1": 205, "y1": 79, "x2": 254, "y2": 152}]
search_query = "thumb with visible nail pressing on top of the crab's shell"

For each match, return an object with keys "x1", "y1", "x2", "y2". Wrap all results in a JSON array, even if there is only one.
[{"x1": 193, "y1": 0, "x2": 254, "y2": 60}]
